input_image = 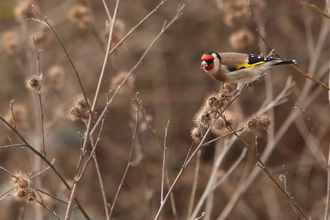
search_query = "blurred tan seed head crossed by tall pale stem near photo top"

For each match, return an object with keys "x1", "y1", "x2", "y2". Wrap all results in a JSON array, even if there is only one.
[{"x1": 101, "y1": 18, "x2": 125, "y2": 47}]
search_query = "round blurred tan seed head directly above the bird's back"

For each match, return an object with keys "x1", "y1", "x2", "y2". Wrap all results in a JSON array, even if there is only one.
[{"x1": 229, "y1": 29, "x2": 254, "y2": 49}]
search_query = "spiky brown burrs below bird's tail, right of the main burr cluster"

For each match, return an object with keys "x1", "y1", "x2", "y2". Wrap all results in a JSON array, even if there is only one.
[{"x1": 246, "y1": 113, "x2": 271, "y2": 132}]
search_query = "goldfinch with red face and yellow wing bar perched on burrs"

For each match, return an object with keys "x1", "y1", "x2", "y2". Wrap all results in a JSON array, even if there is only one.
[{"x1": 201, "y1": 52, "x2": 297, "y2": 90}]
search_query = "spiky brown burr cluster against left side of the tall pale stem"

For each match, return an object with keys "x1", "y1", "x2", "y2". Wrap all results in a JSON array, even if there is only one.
[{"x1": 68, "y1": 95, "x2": 90, "y2": 124}]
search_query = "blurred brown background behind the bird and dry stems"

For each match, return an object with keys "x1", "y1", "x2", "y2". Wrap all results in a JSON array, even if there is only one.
[{"x1": 0, "y1": 0, "x2": 330, "y2": 219}]
